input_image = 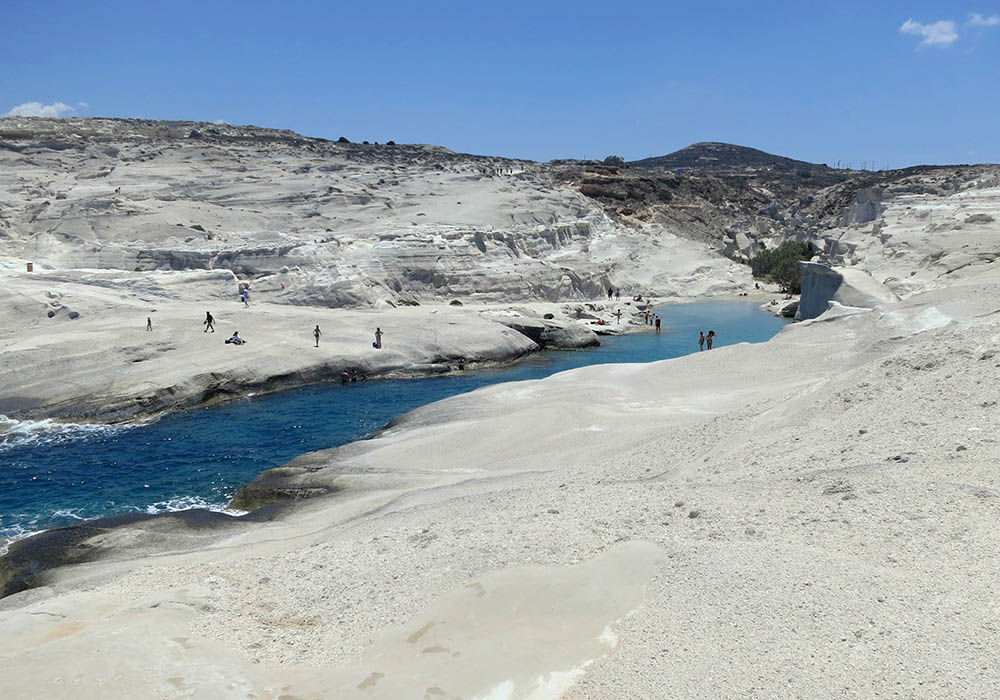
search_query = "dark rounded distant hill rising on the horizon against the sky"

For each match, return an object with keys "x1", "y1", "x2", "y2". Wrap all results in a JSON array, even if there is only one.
[{"x1": 629, "y1": 142, "x2": 836, "y2": 175}]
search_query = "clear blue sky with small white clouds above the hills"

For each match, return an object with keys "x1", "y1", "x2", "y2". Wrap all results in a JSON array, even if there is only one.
[{"x1": 0, "y1": 0, "x2": 1000, "y2": 167}]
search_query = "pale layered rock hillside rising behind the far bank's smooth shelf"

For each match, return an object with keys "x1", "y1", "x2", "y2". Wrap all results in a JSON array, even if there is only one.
[{"x1": 0, "y1": 118, "x2": 747, "y2": 307}]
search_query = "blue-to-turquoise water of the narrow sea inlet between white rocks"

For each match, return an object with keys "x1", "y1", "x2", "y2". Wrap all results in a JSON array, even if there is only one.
[{"x1": 0, "y1": 302, "x2": 785, "y2": 544}]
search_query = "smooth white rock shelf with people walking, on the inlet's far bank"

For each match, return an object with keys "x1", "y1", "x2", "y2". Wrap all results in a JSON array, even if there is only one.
[{"x1": 0, "y1": 304, "x2": 564, "y2": 425}]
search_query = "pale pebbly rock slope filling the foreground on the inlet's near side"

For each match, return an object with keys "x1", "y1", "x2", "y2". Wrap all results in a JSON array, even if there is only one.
[{"x1": 0, "y1": 264, "x2": 1000, "y2": 699}]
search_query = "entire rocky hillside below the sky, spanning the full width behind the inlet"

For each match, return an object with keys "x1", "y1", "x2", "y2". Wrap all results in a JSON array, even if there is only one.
[{"x1": 0, "y1": 118, "x2": 1000, "y2": 307}]
